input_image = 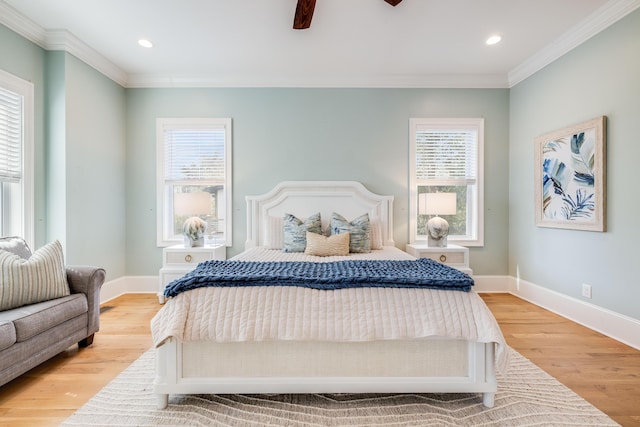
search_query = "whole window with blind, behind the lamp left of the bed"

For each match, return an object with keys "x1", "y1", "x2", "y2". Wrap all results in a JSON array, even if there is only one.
[{"x1": 156, "y1": 118, "x2": 232, "y2": 246}]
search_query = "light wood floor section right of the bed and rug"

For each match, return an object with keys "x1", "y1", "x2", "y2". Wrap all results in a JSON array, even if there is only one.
[{"x1": 481, "y1": 294, "x2": 640, "y2": 427}]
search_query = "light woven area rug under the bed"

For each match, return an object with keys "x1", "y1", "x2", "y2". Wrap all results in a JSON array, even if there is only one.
[{"x1": 62, "y1": 349, "x2": 618, "y2": 427}]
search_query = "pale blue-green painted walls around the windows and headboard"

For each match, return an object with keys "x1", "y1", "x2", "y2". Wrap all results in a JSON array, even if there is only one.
[{"x1": 0, "y1": 11, "x2": 640, "y2": 319}]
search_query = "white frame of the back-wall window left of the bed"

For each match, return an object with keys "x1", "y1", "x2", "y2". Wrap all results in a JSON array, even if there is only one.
[{"x1": 156, "y1": 118, "x2": 233, "y2": 247}]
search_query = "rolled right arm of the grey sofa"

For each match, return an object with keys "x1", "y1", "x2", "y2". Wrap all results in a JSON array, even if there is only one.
[{"x1": 66, "y1": 265, "x2": 106, "y2": 336}]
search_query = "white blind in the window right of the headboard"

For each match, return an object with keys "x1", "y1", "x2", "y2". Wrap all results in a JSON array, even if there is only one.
[{"x1": 415, "y1": 128, "x2": 478, "y2": 184}]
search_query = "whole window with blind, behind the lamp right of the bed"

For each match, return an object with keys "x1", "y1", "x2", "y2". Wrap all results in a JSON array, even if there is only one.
[{"x1": 409, "y1": 118, "x2": 484, "y2": 246}]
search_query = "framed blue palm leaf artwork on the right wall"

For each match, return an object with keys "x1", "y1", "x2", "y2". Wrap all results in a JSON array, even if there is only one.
[{"x1": 534, "y1": 116, "x2": 606, "y2": 231}]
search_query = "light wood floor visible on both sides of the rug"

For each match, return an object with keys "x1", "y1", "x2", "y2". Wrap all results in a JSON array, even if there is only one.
[{"x1": 0, "y1": 294, "x2": 640, "y2": 427}]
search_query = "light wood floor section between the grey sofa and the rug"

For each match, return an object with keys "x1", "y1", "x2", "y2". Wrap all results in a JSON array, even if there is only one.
[{"x1": 0, "y1": 294, "x2": 161, "y2": 427}]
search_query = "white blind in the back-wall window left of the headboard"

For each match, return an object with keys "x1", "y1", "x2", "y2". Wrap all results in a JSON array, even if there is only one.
[{"x1": 164, "y1": 126, "x2": 225, "y2": 183}]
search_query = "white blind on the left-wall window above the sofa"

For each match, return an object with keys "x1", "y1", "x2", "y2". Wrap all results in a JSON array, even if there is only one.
[{"x1": 0, "y1": 88, "x2": 23, "y2": 183}]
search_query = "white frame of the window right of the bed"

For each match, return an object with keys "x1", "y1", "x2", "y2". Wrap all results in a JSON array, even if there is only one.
[{"x1": 409, "y1": 118, "x2": 484, "y2": 246}]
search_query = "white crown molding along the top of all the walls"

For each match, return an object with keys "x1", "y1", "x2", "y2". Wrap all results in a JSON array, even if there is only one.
[{"x1": 0, "y1": 0, "x2": 640, "y2": 89}]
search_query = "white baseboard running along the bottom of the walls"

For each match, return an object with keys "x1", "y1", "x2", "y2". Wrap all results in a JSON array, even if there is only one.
[{"x1": 110, "y1": 276, "x2": 640, "y2": 350}]
